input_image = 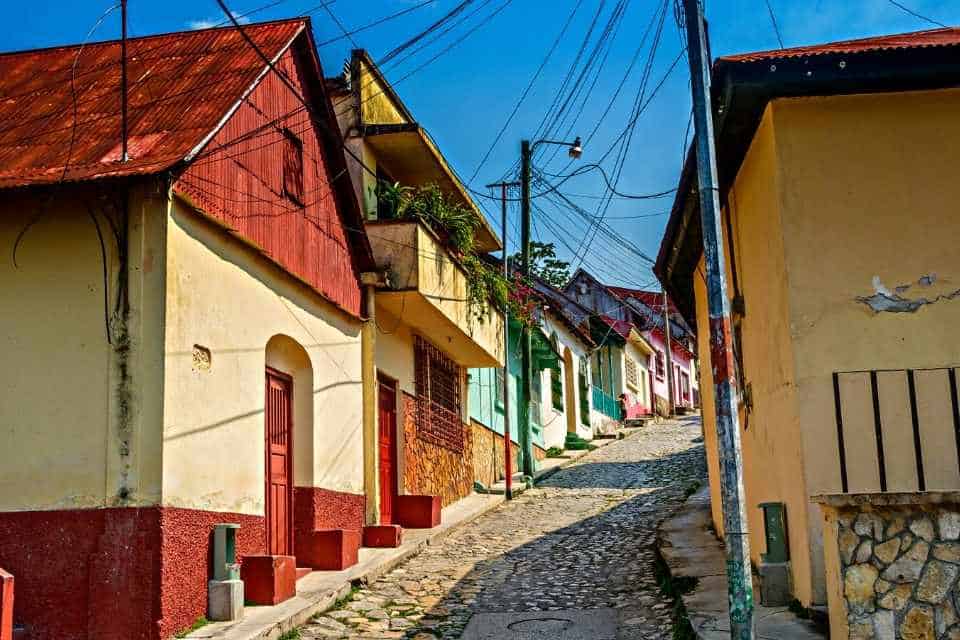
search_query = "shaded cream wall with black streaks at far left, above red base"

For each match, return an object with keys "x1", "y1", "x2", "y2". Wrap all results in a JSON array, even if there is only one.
[{"x1": 0, "y1": 187, "x2": 163, "y2": 511}]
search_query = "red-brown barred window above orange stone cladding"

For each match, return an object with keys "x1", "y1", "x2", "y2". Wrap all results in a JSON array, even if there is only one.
[{"x1": 414, "y1": 336, "x2": 463, "y2": 453}]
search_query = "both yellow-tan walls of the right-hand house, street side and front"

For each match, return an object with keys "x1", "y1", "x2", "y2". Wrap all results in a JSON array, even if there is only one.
[{"x1": 694, "y1": 90, "x2": 960, "y2": 604}]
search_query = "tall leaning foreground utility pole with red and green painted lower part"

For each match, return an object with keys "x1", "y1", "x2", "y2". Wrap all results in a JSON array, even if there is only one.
[{"x1": 683, "y1": 0, "x2": 755, "y2": 640}]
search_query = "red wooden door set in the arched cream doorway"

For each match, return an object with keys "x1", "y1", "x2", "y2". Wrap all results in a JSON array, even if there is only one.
[{"x1": 264, "y1": 368, "x2": 293, "y2": 556}]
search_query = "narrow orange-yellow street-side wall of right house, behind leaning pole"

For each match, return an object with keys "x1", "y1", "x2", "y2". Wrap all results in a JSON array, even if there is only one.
[{"x1": 697, "y1": 111, "x2": 817, "y2": 605}]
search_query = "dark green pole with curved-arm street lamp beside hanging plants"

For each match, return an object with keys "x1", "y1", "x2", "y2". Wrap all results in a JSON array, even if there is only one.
[{"x1": 516, "y1": 136, "x2": 583, "y2": 477}]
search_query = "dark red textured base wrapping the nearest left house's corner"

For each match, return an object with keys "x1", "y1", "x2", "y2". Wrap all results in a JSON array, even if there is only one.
[{"x1": 0, "y1": 507, "x2": 265, "y2": 640}]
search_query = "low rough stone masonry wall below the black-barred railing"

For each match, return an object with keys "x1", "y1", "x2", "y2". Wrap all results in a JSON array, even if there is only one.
[{"x1": 837, "y1": 505, "x2": 960, "y2": 640}]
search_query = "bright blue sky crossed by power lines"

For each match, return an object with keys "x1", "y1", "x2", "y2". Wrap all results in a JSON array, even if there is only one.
[{"x1": 0, "y1": 0, "x2": 960, "y2": 288}]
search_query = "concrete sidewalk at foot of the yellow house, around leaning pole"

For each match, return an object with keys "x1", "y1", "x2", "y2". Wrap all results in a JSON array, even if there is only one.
[{"x1": 657, "y1": 486, "x2": 826, "y2": 640}]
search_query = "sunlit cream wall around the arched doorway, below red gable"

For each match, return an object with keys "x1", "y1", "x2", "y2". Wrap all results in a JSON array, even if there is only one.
[{"x1": 163, "y1": 200, "x2": 363, "y2": 514}]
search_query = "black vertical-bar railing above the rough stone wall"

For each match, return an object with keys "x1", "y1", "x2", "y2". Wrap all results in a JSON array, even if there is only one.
[{"x1": 833, "y1": 367, "x2": 960, "y2": 493}]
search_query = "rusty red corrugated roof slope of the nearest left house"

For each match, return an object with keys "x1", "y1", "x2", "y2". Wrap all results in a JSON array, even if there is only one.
[{"x1": 0, "y1": 19, "x2": 305, "y2": 188}]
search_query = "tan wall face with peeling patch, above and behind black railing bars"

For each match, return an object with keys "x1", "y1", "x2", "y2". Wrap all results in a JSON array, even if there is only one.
[{"x1": 773, "y1": 90, "x2": 960, "y2": 604}]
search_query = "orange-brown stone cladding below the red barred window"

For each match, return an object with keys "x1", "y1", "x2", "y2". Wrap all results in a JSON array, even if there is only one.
[{"x1": 403, "y1": 393, "x2": 474, "y2": 507}]
